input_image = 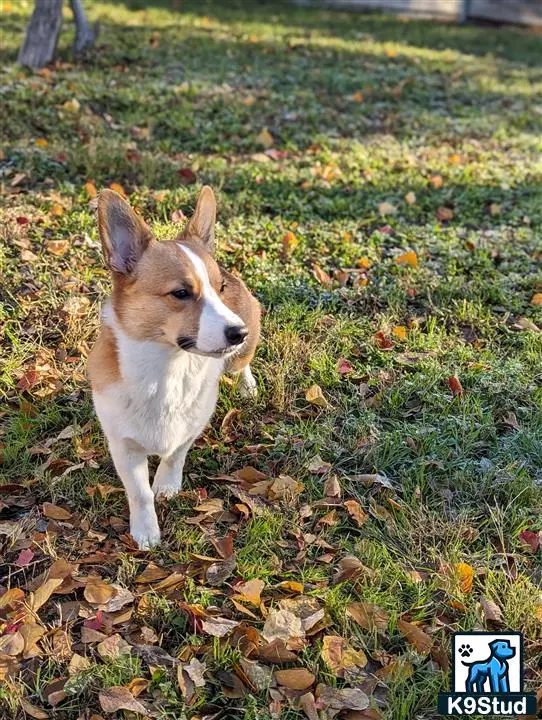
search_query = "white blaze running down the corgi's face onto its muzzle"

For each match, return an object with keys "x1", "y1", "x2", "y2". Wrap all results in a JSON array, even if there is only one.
[{"x1": 177, "y1": 243, "x2": 244, "y2": 352}]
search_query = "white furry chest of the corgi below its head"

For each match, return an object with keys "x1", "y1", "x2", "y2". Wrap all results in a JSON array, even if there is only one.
[{"x1": 94, "y1": 336, "x2": 223, "y2": 456}]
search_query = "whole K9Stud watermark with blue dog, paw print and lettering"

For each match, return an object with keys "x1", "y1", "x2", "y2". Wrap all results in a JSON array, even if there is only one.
[{"x1": 438, "y1": 632, "x2": 536, "y2": 717}]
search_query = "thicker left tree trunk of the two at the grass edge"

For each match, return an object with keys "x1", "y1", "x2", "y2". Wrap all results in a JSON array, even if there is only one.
[{"x1": 18, "y1": 0, "x2": 62, "y2": 68}]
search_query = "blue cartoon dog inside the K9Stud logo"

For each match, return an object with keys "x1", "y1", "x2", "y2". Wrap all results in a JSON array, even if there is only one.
[{"x1": 464, "y1": 639, "x2": 516, "y2": 693}]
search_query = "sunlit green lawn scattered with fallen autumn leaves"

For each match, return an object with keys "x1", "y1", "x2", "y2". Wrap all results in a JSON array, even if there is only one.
[{"x1": 0, "y1": 0, "x2": 542, "y2": 720}]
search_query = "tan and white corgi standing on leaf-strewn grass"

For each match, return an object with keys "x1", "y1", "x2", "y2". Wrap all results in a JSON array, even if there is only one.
[{"x1": 88, "y1": 187, "x2": 260, "y2": 549}]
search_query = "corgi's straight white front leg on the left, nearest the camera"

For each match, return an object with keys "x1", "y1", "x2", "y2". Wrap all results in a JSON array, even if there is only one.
[{"x1": 108, "y1": 438, "x2": 160, "y2": 550}]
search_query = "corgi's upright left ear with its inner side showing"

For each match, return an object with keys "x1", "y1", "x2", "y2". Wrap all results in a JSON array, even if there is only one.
[{"x1": 98, "y1": 190, "x2": 153, "y2": 275}]
